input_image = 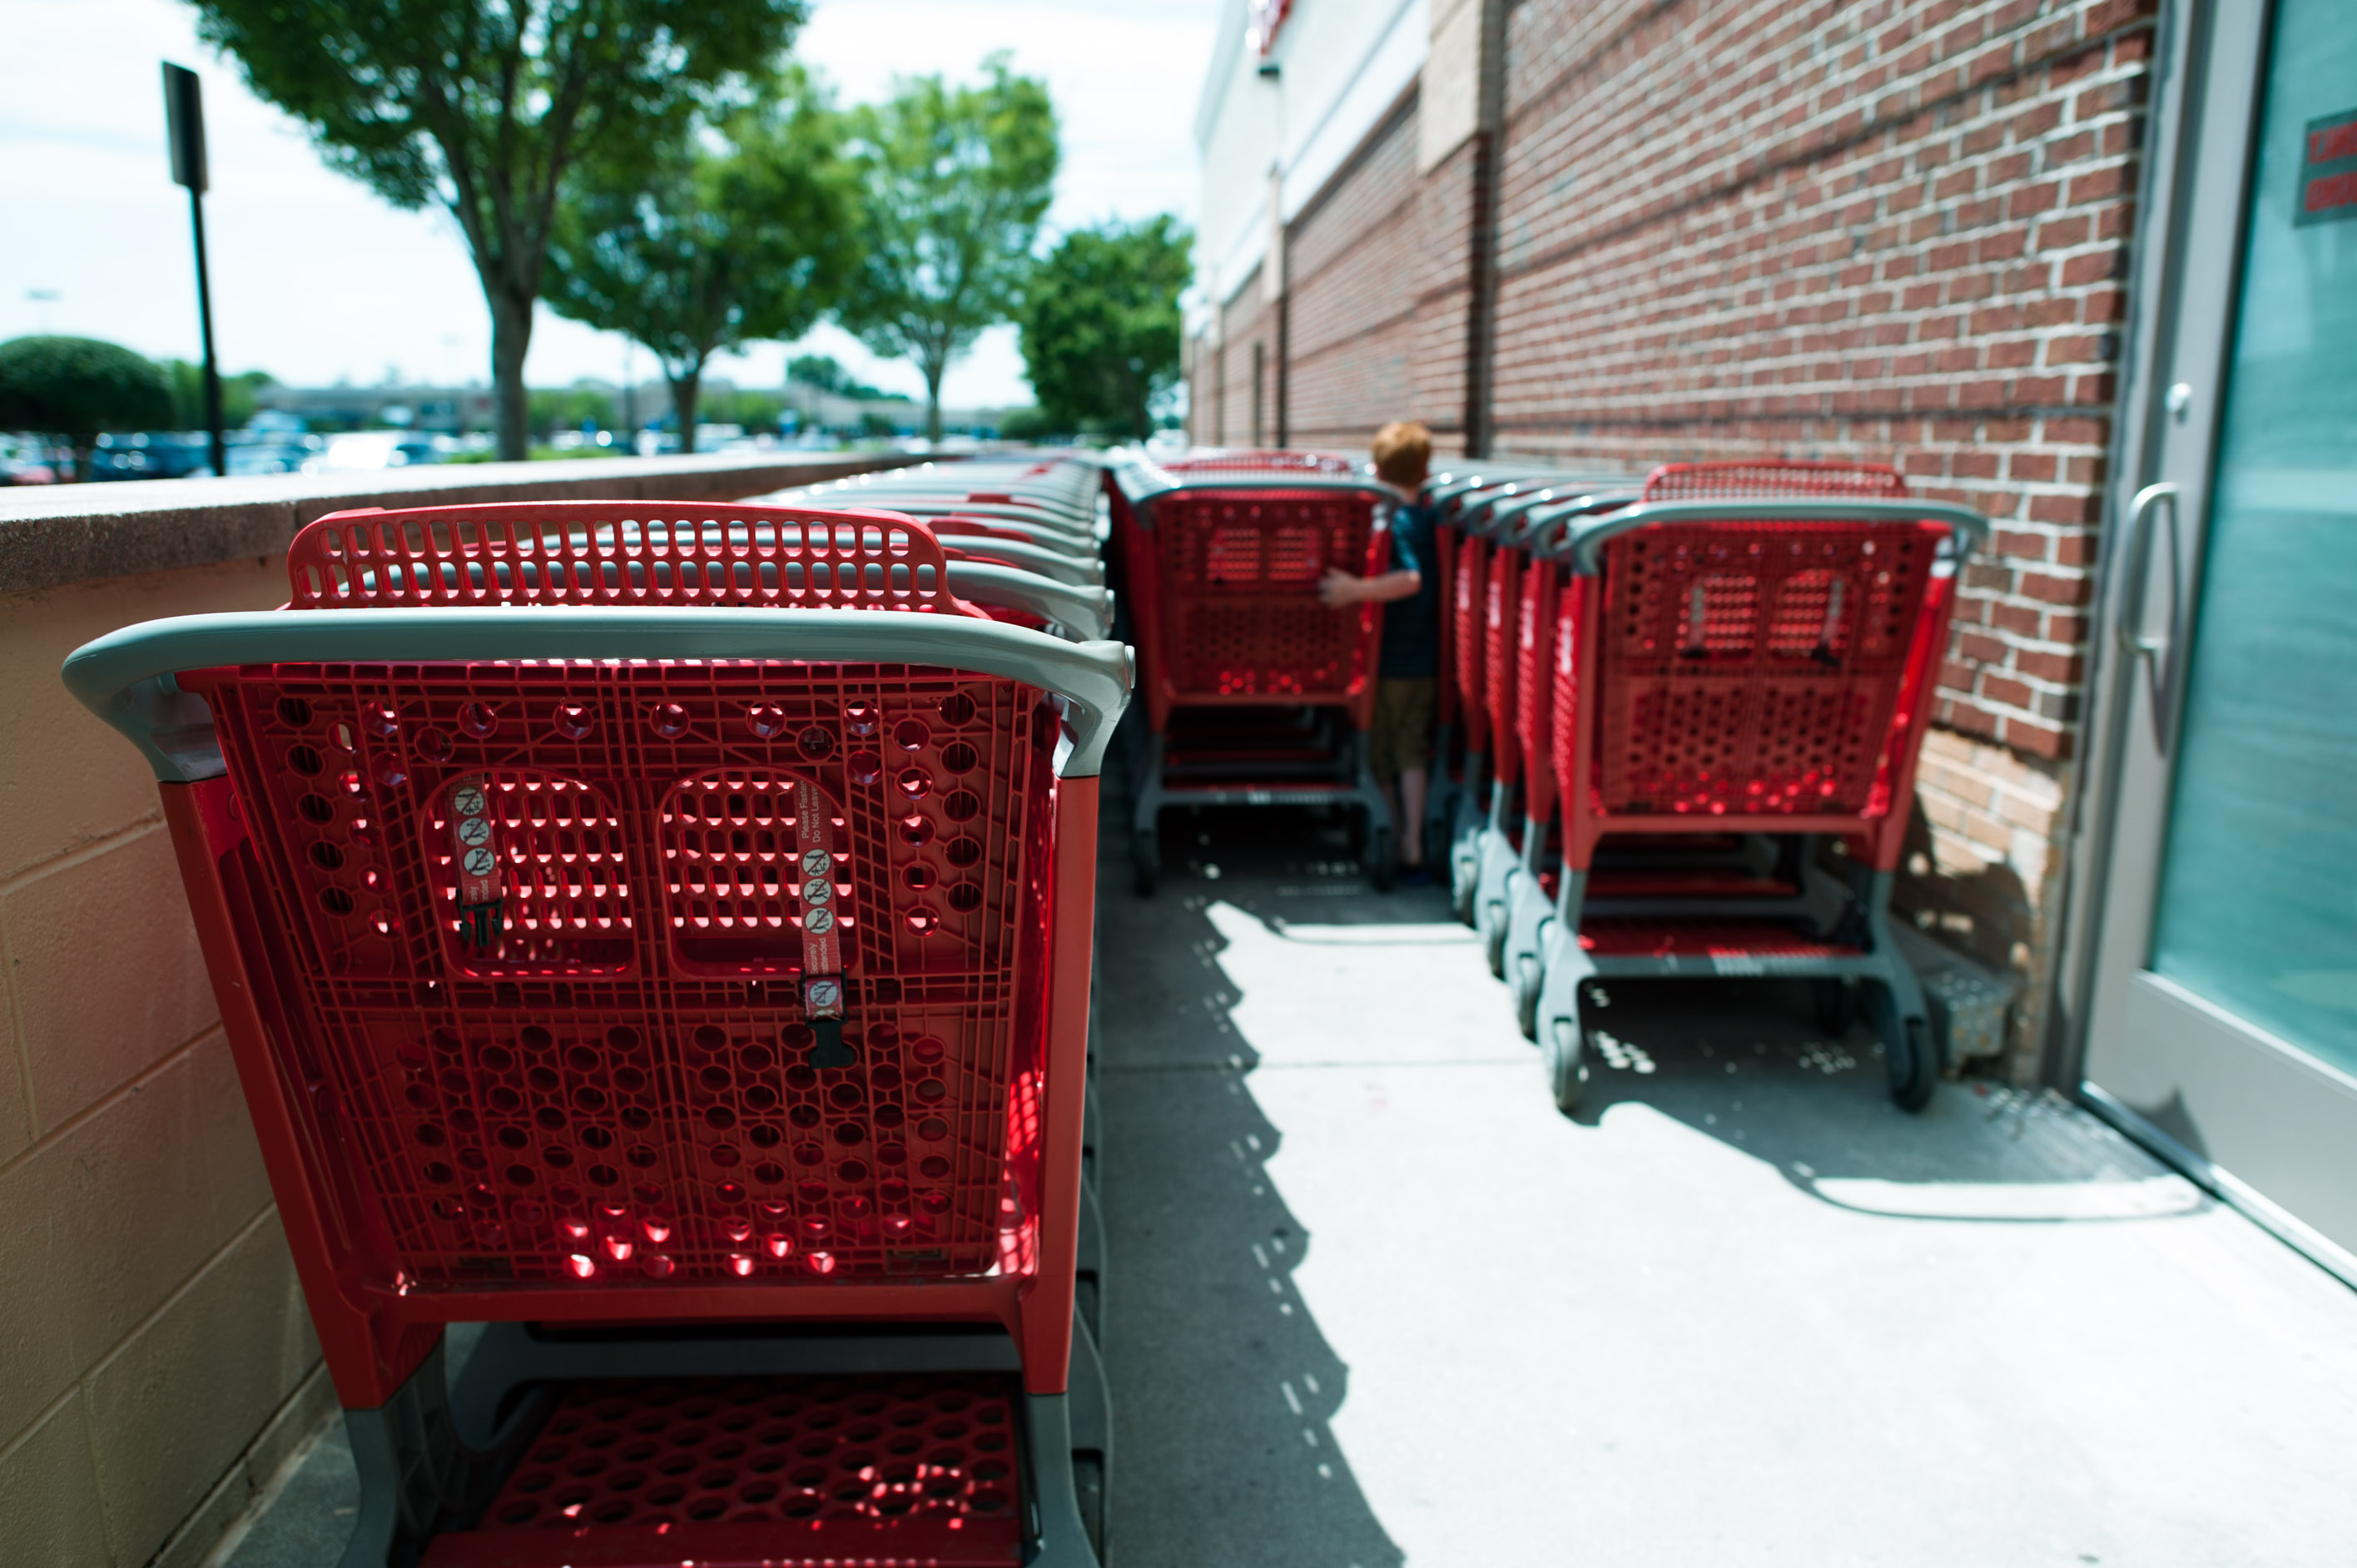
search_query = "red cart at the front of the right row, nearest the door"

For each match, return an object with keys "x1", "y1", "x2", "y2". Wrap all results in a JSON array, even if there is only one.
[{"x1": 1527, "y1": 462, "x2": 1987, "y2": 1110}]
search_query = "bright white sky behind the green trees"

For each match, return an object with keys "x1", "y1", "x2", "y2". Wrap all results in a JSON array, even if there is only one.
[{"x1": 0, "y1": 0, "x2": 1218, "y2": 405}]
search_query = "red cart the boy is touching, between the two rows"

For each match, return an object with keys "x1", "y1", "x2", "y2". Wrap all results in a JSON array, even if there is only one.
[{"x1": 1113, "y1": 453, "x2": 1400, "y2": 894}]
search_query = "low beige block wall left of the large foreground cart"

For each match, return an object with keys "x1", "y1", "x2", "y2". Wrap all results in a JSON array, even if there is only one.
[{"x1": 0, "y1": 558, "x2": 335, "y2": 1568}]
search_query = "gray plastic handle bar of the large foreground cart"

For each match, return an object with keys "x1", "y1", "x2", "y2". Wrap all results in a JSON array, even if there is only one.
[{"x1": 62, "y1": 603, "x2": 1131, "y2": 783}]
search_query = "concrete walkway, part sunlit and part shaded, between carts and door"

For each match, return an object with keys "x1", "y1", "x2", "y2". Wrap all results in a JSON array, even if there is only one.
[{"x1": 229, "y1": 792, "x2": 2357, "y2": 1568}]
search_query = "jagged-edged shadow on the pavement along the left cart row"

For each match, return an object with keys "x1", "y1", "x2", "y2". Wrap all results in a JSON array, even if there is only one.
[{"x1": 1099, "y1": 790, "x2": 1404, "y2": 1568}]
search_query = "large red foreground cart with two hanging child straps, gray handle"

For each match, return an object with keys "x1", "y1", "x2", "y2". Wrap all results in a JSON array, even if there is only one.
[{"x1": 52, "y1": 502, "x2": 1129, "y2": 1568}]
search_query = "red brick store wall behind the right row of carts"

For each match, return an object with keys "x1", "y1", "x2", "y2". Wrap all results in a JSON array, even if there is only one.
[{"x1": 1226, "y1": 0, "x2": 2156, "y2": 1078}]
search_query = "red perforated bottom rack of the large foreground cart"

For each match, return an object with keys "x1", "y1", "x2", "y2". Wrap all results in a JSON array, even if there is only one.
[{"x1": 445, "y1": 1375, "x2": 1023, "y2": 1563}]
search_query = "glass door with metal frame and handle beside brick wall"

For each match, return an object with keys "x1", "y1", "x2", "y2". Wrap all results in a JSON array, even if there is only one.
[{"x1": 2086, "y1": 0, "x2": 2357, "y2": 1280}]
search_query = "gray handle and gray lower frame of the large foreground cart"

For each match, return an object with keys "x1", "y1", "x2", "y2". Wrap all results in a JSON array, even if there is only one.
[{"x1": 62, "y1": 606, "x2": 1131, "y2": 1568}]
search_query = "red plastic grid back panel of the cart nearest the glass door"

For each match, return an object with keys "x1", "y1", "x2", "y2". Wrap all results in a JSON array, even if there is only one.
[{"x1": 1595, "y1": 523, "x2": 1943, "y2": 813}]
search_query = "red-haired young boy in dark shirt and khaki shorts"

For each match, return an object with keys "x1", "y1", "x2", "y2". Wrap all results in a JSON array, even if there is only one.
[{"x1": 1317, "y1": 419, "x2": 1440, "y2": 886}]
